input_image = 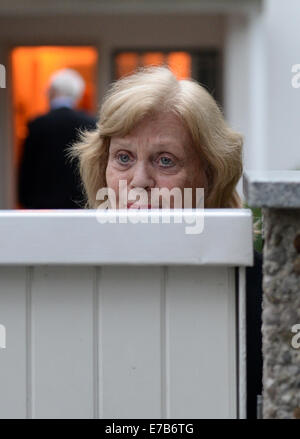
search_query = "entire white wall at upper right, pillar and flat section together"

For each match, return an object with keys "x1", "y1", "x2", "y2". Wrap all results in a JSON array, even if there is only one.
[{"x1": 224, "y1": 0, "x2": 300, "y2": 175}]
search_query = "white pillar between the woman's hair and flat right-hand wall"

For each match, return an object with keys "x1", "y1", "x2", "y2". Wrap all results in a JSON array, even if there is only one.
[{"x1": 224, "y1": 4, "x2": 267, "y2": 182}]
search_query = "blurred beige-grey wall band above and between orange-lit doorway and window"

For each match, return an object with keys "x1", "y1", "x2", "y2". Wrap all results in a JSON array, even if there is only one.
[{"x1": 0, "y1": 14, "x2": 223, "y2": 108}]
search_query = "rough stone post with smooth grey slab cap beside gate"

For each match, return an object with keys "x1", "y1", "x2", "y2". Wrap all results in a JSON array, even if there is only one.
[{"x1": 244, "y1": 171, "x2": 300, "y2": 419}]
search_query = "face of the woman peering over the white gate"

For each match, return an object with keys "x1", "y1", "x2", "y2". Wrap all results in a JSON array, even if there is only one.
[{"x1": 106, "y1": 113, "x2": 207, "y2": 208}]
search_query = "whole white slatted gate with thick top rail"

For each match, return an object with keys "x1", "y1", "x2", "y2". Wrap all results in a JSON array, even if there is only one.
[{"x1": 0, "y1": 209, "x2": 253, "y2": 419}]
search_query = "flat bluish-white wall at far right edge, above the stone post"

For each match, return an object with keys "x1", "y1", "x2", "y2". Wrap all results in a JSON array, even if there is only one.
[{"x1": 265, "y1": 0, "x2": 300, "y2": 169}]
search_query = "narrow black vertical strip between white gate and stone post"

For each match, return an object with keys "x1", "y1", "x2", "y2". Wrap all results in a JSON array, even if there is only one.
[{"x1": 246, "y1": 251, "x2": 263, "y2": 419}]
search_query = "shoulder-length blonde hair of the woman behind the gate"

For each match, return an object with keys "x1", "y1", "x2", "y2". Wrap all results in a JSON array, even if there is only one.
[{"x1": 69, "y1": 67, "x2": 243, "y2": 208}]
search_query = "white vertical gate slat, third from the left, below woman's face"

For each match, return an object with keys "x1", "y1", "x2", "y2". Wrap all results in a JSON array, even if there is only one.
[{"x1": 99, "y1": 267, "x2": 162, "y2": 419}]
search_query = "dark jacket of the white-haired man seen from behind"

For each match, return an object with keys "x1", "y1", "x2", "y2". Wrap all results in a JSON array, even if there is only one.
[{"x1": 18, "y1": 107, "x2": 96, "y2": 209}]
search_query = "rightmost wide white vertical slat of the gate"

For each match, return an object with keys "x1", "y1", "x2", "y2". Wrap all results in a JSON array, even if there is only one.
[{"x1": 166, "y1": 267, "x2": 237, "y2": 419}]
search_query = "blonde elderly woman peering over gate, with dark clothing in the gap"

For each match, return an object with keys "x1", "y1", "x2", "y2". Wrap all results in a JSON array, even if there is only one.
[{"x1": 72, "y1": 67, "x2": 262, "y2": 418}]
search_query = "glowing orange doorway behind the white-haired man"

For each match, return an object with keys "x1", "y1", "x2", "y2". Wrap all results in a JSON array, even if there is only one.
[{"x1": 11, "y1": 46, "x2": 98, "y2": 208}]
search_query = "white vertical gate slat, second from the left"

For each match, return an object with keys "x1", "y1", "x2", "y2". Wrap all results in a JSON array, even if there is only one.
[{"x1": 31, "y1": 266, "x2": 95, "y2": 418}]
